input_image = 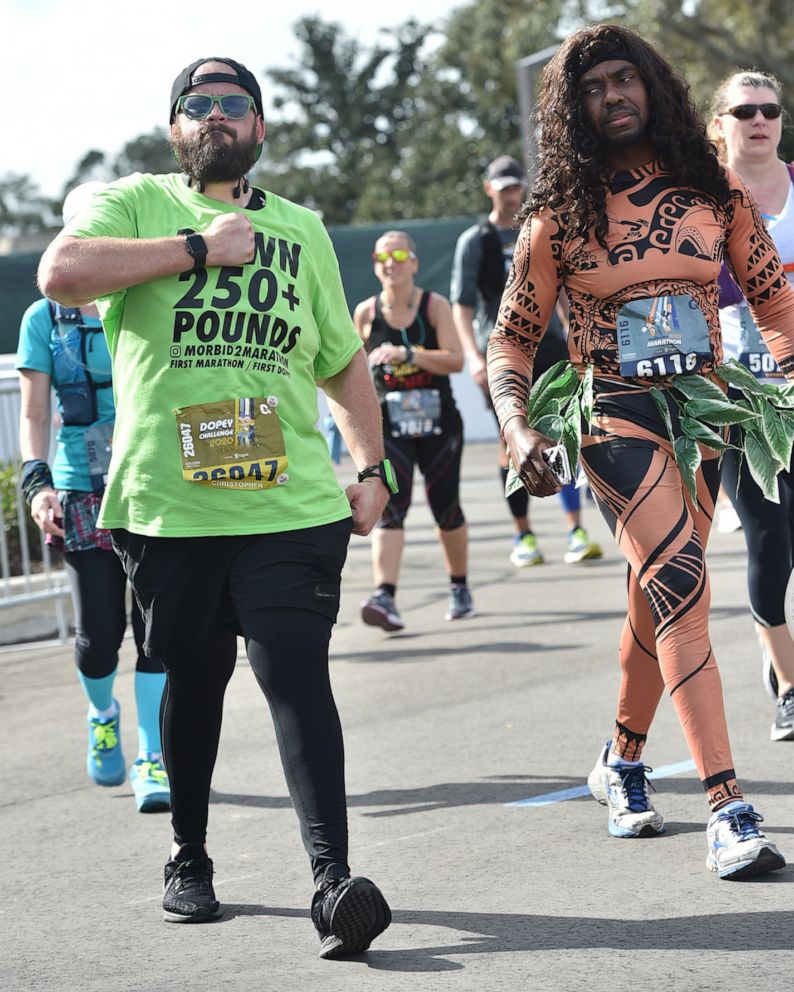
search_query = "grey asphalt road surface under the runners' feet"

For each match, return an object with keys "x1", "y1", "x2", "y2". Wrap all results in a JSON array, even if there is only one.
[{"x1": 0, "y1": 444, "x2": 794, "y2": 992}]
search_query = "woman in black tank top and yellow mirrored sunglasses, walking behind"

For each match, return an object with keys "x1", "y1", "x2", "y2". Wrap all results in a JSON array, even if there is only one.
[{"x1": 353, "y1": 231, "x2": 474, "y2": 631}]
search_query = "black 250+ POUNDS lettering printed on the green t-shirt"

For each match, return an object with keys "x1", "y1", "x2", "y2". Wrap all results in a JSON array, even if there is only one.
[{"x1": 170, "y1": 230, "x2": 301, "y2": 376}]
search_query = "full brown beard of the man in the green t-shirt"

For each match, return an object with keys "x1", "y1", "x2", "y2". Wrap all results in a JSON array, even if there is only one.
[{"x1": 171, "y1": 121, "x2": 258, "y2": 185}]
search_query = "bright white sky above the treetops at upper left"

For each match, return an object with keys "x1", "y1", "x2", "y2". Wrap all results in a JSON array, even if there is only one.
[{"x1": 6, "y1": 0, "x2": 460, "y2": 197}]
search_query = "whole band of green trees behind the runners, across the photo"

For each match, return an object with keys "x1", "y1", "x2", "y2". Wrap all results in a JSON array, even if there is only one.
[{"x1": 6, "y1": 0, "x2": 794, "y2": 233}]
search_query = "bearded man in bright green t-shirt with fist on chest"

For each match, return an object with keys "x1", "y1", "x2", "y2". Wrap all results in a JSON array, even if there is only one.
[{"x1": 39, "y1": 58, "x2": 393, "y2": 957}]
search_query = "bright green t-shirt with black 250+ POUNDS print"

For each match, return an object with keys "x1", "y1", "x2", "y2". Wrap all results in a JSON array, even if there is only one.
[{"x1": 66, "y1": 174, "x2": 361, "y2": 537}]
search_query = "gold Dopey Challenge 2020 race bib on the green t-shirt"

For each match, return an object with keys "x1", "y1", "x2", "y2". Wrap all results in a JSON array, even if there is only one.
[{"x1": 174, "y1": 396, "x2": 289, "y2": 490}]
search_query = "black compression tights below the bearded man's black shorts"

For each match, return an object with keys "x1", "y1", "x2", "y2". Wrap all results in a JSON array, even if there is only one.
[{"x1": 162, "y1": 609, "x2": 347, "y2": 880}]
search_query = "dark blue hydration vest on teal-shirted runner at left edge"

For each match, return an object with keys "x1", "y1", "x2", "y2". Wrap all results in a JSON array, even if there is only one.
[{"x1": 50, "y1": 301, "x2": 113, "y2": 427}]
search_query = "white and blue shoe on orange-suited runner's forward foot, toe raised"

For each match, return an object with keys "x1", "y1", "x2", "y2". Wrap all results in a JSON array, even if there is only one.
[{"x1": 706, "y1": 800, "x2": 786, "y2": 879}]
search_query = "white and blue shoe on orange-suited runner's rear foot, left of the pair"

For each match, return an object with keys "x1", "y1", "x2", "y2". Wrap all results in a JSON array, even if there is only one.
[{"x1": 587, "y1": 741, "x2": 664, "y2": 837}]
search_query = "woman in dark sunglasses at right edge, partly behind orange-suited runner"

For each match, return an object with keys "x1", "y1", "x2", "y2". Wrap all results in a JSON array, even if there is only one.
[{"x1": 712, "y1": 71, "x2": 794, "y2": 741}]
